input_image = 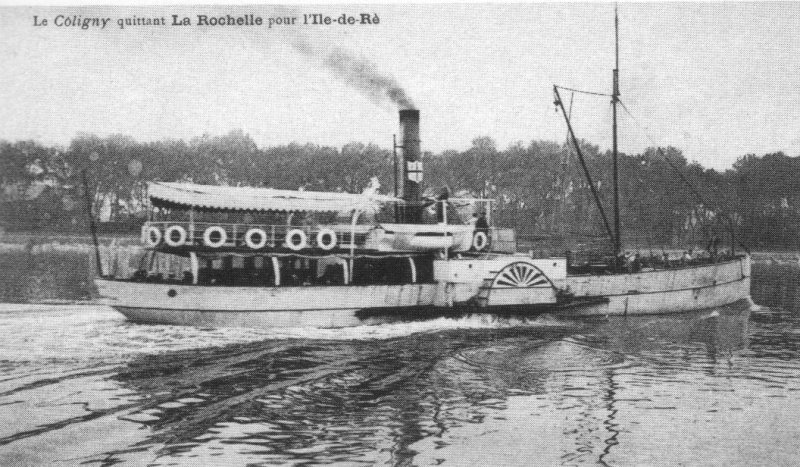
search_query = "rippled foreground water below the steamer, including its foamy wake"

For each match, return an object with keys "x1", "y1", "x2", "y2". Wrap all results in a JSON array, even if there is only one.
[{"x1": 0, "y1": 269, "x2": 800, "y2": 465}]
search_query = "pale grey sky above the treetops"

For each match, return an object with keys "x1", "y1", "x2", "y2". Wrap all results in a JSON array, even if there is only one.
[{"x1": 0, "y1": 2, "x2": 800, "y2": 170}]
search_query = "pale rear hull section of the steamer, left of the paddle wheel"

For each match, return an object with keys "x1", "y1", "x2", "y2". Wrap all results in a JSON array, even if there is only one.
[{"x1": 95, "y1": 279, "x2": 444, "y2": 327}]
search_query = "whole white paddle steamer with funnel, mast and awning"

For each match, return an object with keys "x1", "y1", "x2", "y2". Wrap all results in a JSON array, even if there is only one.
[{"x1": 96, "y1": 11, "x2": 750, "y2": 327}]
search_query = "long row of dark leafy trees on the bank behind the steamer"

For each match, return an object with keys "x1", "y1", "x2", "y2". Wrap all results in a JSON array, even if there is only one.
[{"x1": 0, "y1": 131, "x2": 800, "y2": 248}]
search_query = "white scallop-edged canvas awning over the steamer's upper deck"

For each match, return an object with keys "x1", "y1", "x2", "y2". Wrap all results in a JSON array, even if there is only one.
[{"x1": 147, "y1": 182, "x2": 402, "y2": 213}]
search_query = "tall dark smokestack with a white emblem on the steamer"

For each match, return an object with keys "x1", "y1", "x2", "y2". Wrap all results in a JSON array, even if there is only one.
[{"x1": 400, "y1": 109, "x2": 422, "y2": 224}]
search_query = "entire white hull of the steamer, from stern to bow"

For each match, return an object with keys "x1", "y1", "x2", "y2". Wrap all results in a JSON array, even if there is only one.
[{"x1": 96, "y1": 257, "x2": 750, "y2": 327}]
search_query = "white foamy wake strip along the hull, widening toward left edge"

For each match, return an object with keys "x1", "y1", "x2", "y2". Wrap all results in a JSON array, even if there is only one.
[{"x1": 0, "y1": 304, "x2": 580, "y2": 362}]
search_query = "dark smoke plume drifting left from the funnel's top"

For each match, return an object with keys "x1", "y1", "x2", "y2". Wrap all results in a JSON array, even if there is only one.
[{"x1": 292, "y1": 39, "x2": 414, "y2": 109}]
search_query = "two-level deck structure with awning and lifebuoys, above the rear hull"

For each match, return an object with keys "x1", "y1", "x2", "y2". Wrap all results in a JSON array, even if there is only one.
[{"x1": 133, "y1": 182, "x2": 516, "y2": 286}]
